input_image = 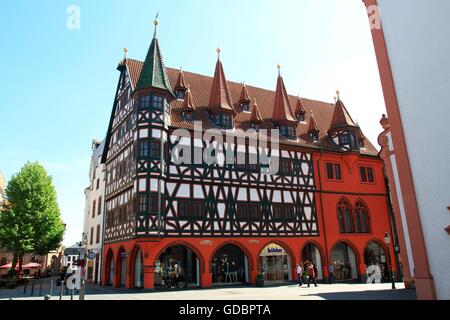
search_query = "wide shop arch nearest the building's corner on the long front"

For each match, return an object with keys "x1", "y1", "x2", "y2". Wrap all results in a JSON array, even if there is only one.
[{"x1": 155, "y1": 245, "x2": 200, "y2": 288}]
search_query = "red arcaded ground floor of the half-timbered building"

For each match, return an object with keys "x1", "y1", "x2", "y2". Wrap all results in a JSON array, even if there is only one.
[{"x1": 102, "y1": 235, "x2": 396, "y2": 289}]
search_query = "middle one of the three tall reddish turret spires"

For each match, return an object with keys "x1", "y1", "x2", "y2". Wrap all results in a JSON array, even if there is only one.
[{"x1": 272, "y1": 65, "x2": 297, "y2": 125}]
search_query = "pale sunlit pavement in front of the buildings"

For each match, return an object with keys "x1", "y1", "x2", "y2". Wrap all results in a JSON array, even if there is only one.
[{"x1": 0, "y1": 280, "x2": 416, "y2": 300}]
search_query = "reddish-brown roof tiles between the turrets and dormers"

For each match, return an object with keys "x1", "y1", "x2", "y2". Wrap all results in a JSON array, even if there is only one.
[{"x1": 121, "y1": 59, "x2": 378, "y2": 155}]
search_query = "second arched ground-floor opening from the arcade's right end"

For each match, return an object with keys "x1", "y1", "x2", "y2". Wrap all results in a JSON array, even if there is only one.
[{"x1": 331, "y1": 242, "x2": 358, "y2": 281}]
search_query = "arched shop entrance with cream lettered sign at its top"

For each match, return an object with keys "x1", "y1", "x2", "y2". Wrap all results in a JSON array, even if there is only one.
[{"x1": 259, "y1": 243, "x2": 292, "y2": 282}]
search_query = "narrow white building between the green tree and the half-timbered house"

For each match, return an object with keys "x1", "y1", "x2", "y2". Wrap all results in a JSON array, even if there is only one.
[{"x1": 84, "y1": 140, "x2": 105, "y2": 283}]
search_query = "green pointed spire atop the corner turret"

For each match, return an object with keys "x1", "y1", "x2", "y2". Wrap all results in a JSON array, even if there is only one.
[{"x1": 136, "y1": 20, "x2": 173, "y2": 97}]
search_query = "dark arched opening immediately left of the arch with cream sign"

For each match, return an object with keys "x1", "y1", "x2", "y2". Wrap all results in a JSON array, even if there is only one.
[{"x1": 211, "y1": 244, "x2": 249, "y2": 285}]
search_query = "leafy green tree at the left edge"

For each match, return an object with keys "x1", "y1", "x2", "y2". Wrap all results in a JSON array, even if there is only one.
[{"x1": 0, "y1": 162, "x2": 65, "y2": 270}]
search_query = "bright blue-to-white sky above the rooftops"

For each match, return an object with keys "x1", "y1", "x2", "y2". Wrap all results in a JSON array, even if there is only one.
[{"x1": 0, "y1": 0, "x2": 385, "y2": 245}]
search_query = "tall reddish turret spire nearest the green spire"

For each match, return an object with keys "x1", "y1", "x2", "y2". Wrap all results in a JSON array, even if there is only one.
[{"x1": 209, "y1": 49, "x2": 236, "y2": 114}]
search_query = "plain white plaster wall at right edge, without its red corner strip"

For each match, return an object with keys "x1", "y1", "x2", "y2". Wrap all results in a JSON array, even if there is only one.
[{"x1": 378, "y1": 0, "x2": 450, "y2": 299}]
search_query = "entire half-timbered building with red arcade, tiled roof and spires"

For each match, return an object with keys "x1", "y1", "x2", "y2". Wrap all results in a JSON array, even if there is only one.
[{"x1": 102, "y1": 20, "x2": 397, "y2": 289}]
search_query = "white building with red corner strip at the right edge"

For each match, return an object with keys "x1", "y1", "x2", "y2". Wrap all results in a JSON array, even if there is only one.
[{"x1": 364, "y1": 0, "x2": 450, "y2": 299}]
